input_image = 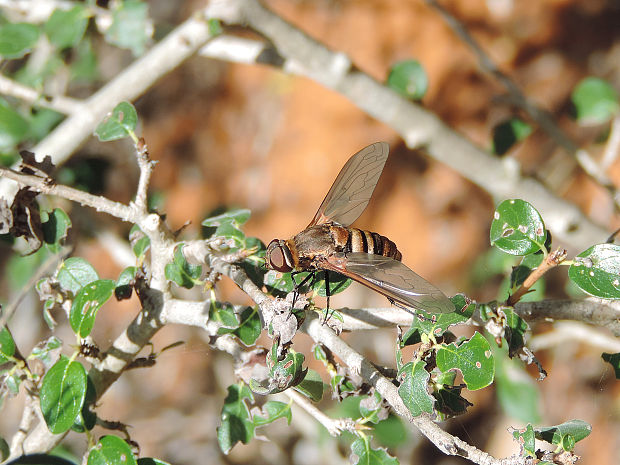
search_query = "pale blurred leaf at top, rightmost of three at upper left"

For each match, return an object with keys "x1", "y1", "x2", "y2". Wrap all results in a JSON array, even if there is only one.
[{"x1": 105, "y1": 0, "x2": 152, "y2": 56}]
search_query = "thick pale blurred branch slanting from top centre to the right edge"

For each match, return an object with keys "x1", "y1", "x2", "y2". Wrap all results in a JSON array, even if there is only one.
[{"x1": 202, "y1": 0, "x2": 609, "y2": 250}]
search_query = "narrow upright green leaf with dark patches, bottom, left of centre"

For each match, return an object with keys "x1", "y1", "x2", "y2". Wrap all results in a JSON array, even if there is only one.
[{"x1": 217, "y1": 383, "x2": 254, "y2": 454}]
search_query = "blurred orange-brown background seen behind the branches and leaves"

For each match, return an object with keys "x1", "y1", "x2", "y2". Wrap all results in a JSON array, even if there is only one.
[{"x1": 0, "y1": 0, "x2": 620, "y2": 465}]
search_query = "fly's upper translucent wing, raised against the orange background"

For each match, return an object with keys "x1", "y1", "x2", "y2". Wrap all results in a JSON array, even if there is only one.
[{"x1": 308, "y1": 142, "x2": 390, "y2": 228}]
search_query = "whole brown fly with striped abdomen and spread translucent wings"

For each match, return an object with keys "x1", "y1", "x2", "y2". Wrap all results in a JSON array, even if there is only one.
[{"x1": 266, "y1": 142, "x2": 454, "y2": 313}]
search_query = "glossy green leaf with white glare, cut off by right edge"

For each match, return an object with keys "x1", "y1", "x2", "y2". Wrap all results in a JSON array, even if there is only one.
[{"x1": 568, "y1": 244, "x2": 620, "y2": 299}]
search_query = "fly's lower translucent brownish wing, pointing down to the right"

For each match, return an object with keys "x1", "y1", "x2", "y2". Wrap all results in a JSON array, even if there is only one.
[{"x1": 320, "y1": 252, "x2": 455, "y2": 313}]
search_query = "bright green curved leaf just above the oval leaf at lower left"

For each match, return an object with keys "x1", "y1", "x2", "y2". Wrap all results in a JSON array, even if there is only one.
[{"x1": 69, "y1": 279, "x2": 116, "y2": 337}]
